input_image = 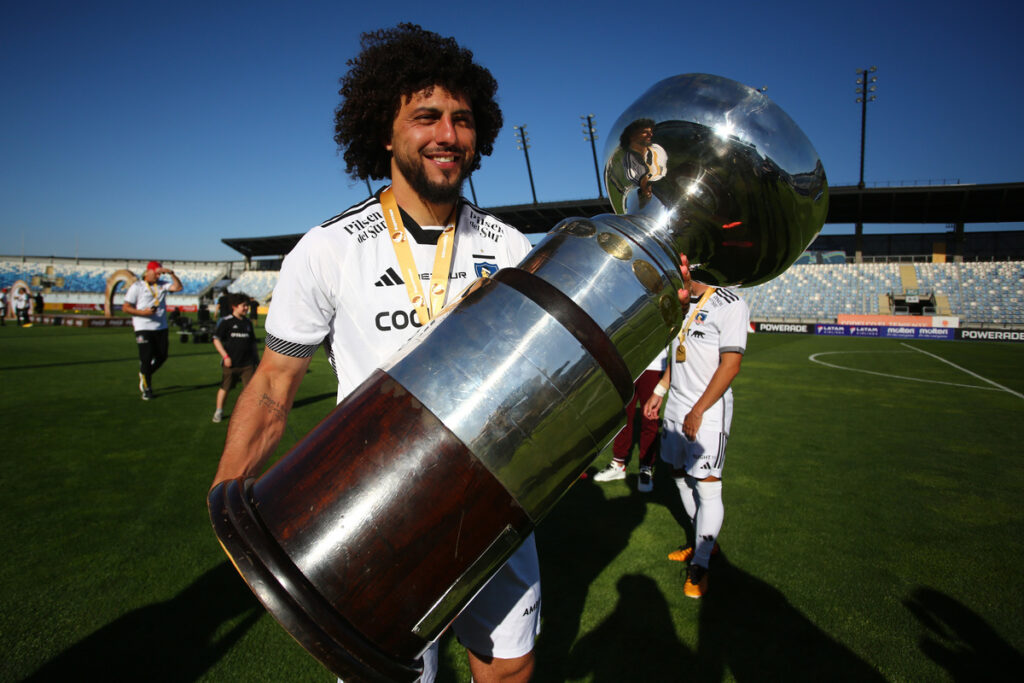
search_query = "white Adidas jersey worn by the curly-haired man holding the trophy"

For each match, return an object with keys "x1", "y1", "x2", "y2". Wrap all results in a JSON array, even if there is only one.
[{"x1": 266, "y1": 188, "x2": 530, "y2": 400}]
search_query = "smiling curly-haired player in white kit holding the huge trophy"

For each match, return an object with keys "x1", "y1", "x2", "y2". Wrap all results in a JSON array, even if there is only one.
[{"x1": 213, "y1": 25, "x2": 541, "y2": 682}]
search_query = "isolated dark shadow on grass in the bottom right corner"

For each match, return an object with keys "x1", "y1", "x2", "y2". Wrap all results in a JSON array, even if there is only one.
[{"x1": 903, "y1": 588, "x2": 1024, "y2": 681}]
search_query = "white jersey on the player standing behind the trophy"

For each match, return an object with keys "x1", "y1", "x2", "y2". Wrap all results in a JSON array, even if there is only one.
[{"x1": 665, "y1": 288, "x2": 750, "y2": 425}]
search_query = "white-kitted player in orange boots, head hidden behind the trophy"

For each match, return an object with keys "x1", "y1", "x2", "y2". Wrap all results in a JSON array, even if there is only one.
[{"x1": 644, "y1": 259, "x2": 750, "y2": 598}]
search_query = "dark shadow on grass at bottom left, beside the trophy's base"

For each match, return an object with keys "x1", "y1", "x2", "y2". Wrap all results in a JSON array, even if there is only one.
[{"x1": 26, "y1": 561, "x2": 263, "y2": 681}]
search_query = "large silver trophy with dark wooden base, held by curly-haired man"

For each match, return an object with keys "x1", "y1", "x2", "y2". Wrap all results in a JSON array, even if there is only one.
[{"x1": 209, "y1": 74, "x2": 827, "y2": 681}]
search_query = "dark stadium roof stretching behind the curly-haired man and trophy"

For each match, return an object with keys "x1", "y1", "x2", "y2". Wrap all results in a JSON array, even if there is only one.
[{"x1": 221, "y1": 182, "x2": 1024, "y2": 260}]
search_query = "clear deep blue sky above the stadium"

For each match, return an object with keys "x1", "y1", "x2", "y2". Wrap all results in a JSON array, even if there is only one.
[{"x1": 0, "y1": 0, "x2": 1024, "y2": 260}]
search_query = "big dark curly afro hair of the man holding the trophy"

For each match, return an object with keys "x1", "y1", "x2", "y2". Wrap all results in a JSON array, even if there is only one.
[{"x1": 334, "y1": 24, "x2": 502, "y2": 179}]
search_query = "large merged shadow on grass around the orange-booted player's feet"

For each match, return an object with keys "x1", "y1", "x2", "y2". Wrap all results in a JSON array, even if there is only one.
[{"x1": 535, "y1": 477, "x2": 884, "y2": 682}]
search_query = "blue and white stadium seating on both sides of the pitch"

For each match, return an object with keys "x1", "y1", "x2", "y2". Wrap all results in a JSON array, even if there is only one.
[{"x1": 0, "y1": 252, "x2": 1024, "y2": 326}]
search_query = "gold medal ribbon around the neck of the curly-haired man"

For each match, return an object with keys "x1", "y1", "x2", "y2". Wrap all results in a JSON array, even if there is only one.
[{"x1": 381, "y1": 187, "x2": 455, "y2": 325}]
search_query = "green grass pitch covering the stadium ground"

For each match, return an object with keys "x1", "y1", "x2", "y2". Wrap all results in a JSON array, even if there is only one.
[{"x1": 0, "y1": 325, "x2": 1024, "y2": 681}]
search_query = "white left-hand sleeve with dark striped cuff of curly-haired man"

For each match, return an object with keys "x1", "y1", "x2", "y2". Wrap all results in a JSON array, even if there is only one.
[{"x1": 266, "y1": 227, "x2": 341, "y2": 358}]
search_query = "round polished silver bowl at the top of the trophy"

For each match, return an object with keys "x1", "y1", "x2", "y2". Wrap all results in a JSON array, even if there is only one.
[{"x1": 604, "y1": 74, "x2": 828, "y2": 287}]
